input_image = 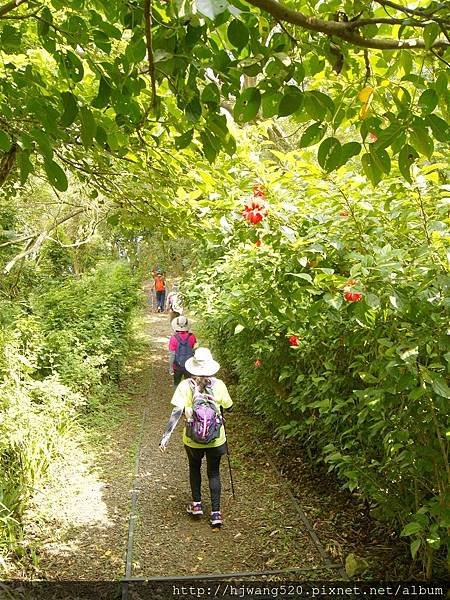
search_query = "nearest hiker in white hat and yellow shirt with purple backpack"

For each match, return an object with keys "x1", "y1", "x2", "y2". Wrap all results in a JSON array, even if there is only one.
[{"x1": 159, "y1": 348, "x2": 233, "y2": 527}]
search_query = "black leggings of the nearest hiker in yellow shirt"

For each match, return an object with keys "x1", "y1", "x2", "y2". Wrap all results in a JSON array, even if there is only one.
[{"x1": 184, "y1": 444, "x2": 226, "y2": 512}]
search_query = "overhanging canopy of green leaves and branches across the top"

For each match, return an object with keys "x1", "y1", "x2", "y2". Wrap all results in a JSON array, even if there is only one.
[{"x1": 0, "y1": 0, "x2": 450, "y2": 196}]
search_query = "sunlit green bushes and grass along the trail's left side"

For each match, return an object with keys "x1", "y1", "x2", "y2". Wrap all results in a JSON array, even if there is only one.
[{"x1": 0, "y1": 262, "x2": 141, "y2": 554}]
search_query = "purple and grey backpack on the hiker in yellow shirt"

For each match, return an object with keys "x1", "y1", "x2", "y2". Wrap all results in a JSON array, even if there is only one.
[{"x1": 186, "y1": 379, "x2": 222, "y2": 444}]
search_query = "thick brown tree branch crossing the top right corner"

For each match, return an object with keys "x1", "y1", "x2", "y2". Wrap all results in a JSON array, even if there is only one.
[{"x1": 246, "y1": 0, "x2": 450, "y2": 50}]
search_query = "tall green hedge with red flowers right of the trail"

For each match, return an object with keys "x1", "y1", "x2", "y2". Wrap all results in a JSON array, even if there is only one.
[{"x1": 185, "y1": 153, "x2": 450, "y2": 576}]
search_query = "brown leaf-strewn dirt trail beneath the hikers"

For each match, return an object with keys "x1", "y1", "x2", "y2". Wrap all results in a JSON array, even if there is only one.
[{"x1": 132, "y1": 314, "x2": 330, "y2": 577}]
